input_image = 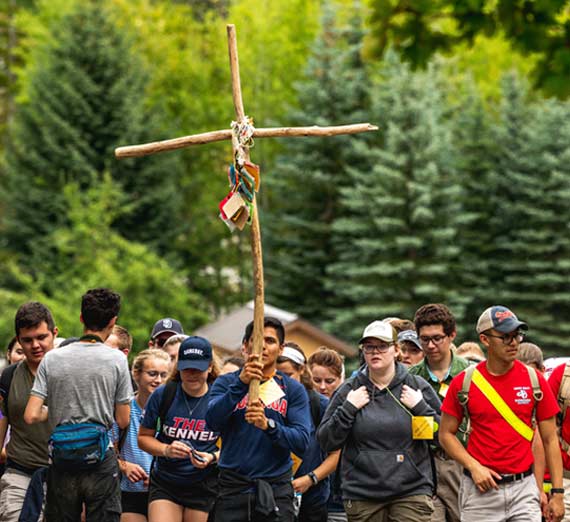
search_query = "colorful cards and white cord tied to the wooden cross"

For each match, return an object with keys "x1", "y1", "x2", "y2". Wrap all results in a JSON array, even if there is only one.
[{"x1": 219, "y1": 116, "x2": 261, "y2": 232}]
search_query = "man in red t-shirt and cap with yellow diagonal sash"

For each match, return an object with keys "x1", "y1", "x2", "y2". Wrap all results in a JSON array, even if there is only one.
[{"x1": 439, "y1": 306, "x2": 564, "y2": 522}]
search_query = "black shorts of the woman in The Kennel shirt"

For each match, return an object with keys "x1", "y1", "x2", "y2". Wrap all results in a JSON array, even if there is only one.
[{"x1": 148, "y1": 472, "x2": 218, "y2": 513}]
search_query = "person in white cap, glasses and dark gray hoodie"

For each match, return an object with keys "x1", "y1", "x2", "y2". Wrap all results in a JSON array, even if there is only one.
[{"x1": 317, "y1": 321, "x2": 440, "y2": 522}]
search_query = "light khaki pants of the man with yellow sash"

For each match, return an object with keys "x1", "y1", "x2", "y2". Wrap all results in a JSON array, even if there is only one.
[{"x1": 459, "y1": 475, "x2": 542, "y2": 522}]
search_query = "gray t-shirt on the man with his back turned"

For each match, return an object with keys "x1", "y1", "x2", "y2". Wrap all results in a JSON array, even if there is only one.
[{"x1": 31, "y1": 342, "x2": 133, "y2": 428}]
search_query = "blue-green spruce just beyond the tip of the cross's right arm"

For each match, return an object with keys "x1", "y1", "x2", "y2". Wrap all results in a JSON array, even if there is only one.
[{"x1": 329, "y1": 55, "x2": 460, "y2": 340}]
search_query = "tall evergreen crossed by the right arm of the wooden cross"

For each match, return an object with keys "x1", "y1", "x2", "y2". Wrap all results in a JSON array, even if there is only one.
[{"x1": 264, "y1": 4, "x2": 370, "y2": 323}]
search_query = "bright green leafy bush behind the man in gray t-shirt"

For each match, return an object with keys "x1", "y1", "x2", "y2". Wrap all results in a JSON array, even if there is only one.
[{"x1": 0, "y1": 175, "x2": 207, "y2": 351}]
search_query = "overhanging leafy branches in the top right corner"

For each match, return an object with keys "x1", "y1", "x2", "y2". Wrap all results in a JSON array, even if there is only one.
[{"x1": 364, "y1": 0, "x2": 570, "y2": 96}]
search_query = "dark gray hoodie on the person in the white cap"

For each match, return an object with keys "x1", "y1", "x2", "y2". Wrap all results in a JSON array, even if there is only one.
[{"x1": 317, "y1": 363, "x2": 441, "y2": 502}]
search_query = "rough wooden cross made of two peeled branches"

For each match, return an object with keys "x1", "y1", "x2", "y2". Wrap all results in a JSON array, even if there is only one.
[{"x1": 115, "y1": 24, "x2": 378, "y2": 401}]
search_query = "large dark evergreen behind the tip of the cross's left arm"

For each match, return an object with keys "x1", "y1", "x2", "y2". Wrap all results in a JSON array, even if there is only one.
[{"x1": 1, "y1": 1, "x2": 179, "y2": 259}]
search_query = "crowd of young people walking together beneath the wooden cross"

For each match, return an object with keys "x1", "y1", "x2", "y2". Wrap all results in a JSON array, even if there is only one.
[{"x1": 0, "y1": 288, "x2": 570, "y2": 522}]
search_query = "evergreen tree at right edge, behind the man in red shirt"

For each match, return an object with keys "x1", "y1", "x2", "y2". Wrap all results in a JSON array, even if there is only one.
[{"x1": 483, "y1": 75, "x2": 570, "y2": 349}]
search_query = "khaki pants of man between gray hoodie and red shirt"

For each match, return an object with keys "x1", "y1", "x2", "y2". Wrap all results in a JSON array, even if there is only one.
[{"x1": 431, "y1": 450, "x2": 463, "y2": 522}]
